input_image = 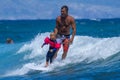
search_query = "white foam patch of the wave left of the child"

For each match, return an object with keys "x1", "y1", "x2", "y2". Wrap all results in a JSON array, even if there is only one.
[{"x1": 17, "y1": 33, "x2": 49, "y2": 59}]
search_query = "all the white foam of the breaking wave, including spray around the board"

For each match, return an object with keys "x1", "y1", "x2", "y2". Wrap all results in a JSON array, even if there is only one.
[{"x1": 3, "y1": 33, "x2": 120, "y2": 75}]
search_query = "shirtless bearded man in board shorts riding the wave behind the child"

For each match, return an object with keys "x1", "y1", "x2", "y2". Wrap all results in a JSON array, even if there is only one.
[{"x1": 54, "y1": 5, "x2": 76, "y2": 60}]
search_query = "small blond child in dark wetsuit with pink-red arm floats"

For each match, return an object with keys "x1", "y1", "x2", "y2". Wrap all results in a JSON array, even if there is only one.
[{"x1": 41, "y1": 33, "x2": 60, "y2": 67}]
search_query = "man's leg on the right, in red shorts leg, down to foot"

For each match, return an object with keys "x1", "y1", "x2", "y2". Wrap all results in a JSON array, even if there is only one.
[{"x1": 62, "y1": 39, "x2": 69, "y2": 60}]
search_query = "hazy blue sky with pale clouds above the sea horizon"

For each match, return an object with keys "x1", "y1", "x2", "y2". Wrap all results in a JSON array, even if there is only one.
[{"x1": 0, "y1": 0, "x2": 120, "y2": 20}]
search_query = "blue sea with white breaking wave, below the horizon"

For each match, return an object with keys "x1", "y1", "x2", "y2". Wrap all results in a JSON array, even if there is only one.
[{"x1": 0, "y1": 18, "x2": 120, "y2": 80}]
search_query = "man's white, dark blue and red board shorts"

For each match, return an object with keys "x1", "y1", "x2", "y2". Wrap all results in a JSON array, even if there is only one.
[{"x1": 56, "y1": 34, "x2": 70, "y2": 52}]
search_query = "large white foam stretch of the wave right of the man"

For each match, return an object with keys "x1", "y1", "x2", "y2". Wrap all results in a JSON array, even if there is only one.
[{"x1": 68, "y1": 36, "x2": 120, "y2": 62}]
